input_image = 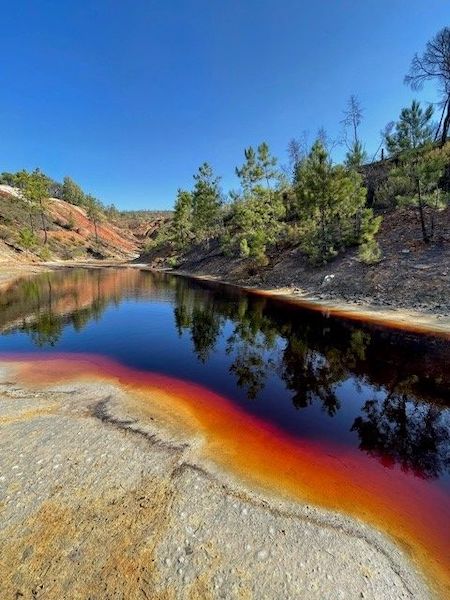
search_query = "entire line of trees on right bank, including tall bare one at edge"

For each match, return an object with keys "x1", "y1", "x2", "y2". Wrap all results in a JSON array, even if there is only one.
[{"x1": 157, "y1": 28, "x2": 450, "y2": 266}]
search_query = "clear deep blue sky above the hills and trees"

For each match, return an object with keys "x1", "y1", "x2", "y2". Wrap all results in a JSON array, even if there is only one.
[{"x1": 0, "y1": 0, "x2": 450, "y2": 208}]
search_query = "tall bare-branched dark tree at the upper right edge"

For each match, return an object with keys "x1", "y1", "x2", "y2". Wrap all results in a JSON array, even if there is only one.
[{"x1": 405, "y1": 27, "x2": 450, "y2": 145}]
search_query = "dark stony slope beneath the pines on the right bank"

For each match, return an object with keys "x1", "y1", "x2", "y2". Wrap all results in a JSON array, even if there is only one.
[{"x1": 138, "y1": 208, "x2": 450, "y2": 315}]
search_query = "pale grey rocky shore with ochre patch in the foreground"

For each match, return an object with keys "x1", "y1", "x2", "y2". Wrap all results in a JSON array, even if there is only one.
[{"x1": 0, "y1": 362, "x2": 433, "y2": 600}]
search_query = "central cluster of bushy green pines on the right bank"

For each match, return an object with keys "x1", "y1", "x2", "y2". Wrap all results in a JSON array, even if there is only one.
[{"x1": 163, "y1": 140, "x2": 381, "y2": 266}]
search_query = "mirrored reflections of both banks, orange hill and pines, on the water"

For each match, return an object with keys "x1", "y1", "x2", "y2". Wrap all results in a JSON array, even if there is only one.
[{"x1": 0, "y1": 269, "x2": 450, "y2": 478}]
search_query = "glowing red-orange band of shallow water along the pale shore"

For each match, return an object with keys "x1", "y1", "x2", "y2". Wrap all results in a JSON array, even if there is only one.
[{"x1": 0, "y1": 354, "x2": 450, "y2": 597}]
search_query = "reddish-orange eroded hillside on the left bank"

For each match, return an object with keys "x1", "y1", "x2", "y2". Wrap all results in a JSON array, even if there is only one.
[{"x1": 0, "y1": 185, "x2": 141, "y2": 262}]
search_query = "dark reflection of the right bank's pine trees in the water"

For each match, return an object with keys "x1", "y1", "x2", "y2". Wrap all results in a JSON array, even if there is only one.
[{"x1": 170, "y1": 279, "x2": 450, "y2": 478}]
